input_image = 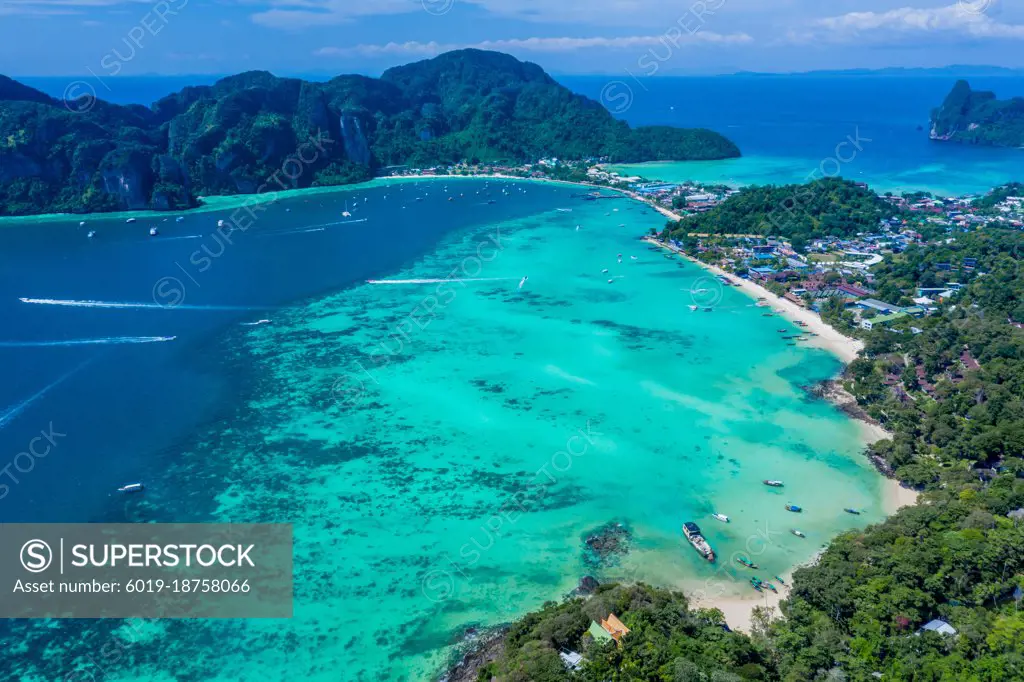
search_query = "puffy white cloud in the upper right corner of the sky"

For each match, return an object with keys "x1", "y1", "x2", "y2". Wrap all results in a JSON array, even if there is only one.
[{"x1": 787, "y1": 0, "x2": 1024, "y2": 43}]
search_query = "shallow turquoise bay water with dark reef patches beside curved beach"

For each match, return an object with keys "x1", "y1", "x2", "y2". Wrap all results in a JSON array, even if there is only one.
[{"x1": 4, "y1": 180, "x2": 883, "y2": 681}]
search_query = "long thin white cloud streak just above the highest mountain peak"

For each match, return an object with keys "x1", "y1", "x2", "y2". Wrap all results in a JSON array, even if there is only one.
[{"x1": 314, "y1": 31, "x2": 754, "y2": 56}]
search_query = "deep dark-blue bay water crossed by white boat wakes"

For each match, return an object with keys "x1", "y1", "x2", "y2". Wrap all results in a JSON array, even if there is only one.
[{"x1": 0, "y1": 180, "x2": 569, "y2": 522}]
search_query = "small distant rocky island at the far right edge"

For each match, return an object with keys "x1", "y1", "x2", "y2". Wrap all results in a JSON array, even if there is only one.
[{"x1": 930, "y1": 81, "x2": 1024, "y2": 147}]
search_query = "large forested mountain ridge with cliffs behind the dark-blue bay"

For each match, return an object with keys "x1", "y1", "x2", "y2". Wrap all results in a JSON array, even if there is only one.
[{"x1": 0, "y1": 49, "x2": 739, "y2": 215}]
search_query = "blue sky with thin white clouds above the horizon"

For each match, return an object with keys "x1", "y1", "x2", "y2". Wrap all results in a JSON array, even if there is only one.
[{"x1": 0, "y1": 0, "x2": 1024, "y2": 76}]
